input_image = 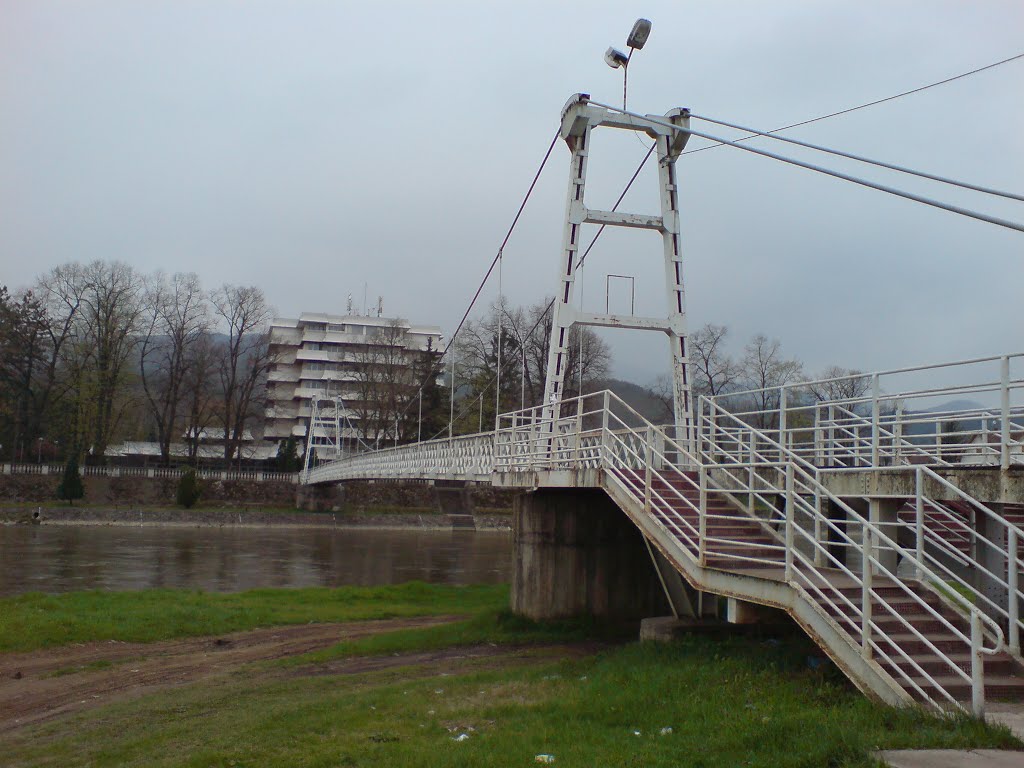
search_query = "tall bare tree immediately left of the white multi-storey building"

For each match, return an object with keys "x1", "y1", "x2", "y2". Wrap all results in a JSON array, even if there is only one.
[{"x1": 211, "y1": 285, "x2": 272, "y2": 464}]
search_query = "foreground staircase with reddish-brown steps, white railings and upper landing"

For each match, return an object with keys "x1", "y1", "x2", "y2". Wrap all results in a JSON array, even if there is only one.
[{"x1": 496, "y1": 393, "x2": 1024, "y2": 715}]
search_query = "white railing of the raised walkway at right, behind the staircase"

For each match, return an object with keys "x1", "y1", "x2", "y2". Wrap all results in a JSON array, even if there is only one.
[{"x1": 711, "y1": 353, "x2": 1024, "y2": 469}]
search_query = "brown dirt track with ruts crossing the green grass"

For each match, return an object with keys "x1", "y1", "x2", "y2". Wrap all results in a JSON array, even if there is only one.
[{"x1": 0, "y1": 616, "x2": 460, "y2": 733}]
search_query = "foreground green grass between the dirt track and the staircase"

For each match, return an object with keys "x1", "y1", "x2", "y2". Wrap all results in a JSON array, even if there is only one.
[{"x1": 0, "y1": 585, "x2": 1020, "y2": 768}]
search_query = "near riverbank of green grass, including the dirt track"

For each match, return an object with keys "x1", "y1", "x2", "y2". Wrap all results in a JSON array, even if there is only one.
[{"x1": 0, "y1": 585, "x2": 1022, "y2": 768}]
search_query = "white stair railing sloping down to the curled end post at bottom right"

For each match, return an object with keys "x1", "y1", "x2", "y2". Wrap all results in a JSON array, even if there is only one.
[{"x1": 698, "y1": 398, "x2": 1004, "y2": 716}]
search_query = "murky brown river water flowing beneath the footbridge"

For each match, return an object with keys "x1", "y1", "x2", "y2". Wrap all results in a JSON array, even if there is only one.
[{"x1": 0, "y1": 525, "x2": 512, "y2": 596}]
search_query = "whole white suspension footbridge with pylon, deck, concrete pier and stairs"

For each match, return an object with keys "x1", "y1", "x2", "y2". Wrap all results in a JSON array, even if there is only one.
[{"x1": 302, "y1": 94, "x2": 1024, "y2": 716}]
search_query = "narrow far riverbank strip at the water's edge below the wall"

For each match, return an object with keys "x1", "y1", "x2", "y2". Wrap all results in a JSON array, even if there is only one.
[{"x1": 0, "y1": 504, "x2": 512, "y2": 530}]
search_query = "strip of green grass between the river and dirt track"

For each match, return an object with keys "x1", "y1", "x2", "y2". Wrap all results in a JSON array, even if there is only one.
[{"x1": 0, "y1": 582, "x2": 508, "y2": 652}]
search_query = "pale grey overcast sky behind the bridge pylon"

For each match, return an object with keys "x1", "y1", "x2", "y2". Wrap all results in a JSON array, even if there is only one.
[{"x1": 0, "y1": 0, "x2": 1024, "y2": 383}]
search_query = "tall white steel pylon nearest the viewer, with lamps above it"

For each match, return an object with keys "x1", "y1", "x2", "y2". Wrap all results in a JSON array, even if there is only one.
[{"x1": 544, "y1": 93, "x2": 694, "y2": 450}]
